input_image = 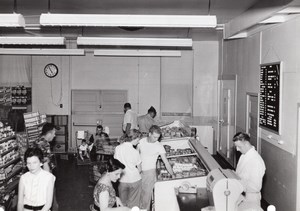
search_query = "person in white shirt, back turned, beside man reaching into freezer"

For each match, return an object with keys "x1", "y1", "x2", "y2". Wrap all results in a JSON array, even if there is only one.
[{"x1": 114, "y1": 129, "x2": 142, "y2": 208}]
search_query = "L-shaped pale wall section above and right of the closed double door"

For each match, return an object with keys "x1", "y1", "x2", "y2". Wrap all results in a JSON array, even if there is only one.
[{"x1": 71, "y1": 54, "x2": 160, "y2": 114}]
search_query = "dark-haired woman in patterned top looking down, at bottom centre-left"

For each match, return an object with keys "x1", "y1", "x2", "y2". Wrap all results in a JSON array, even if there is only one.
[{"x1": 90, "y1": 158, "x2": 130, "y2": 211}]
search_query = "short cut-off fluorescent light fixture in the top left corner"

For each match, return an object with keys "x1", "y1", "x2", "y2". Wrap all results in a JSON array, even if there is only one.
[{"x1": 0, "y1": 13, "x2": 25, "y2": 27}]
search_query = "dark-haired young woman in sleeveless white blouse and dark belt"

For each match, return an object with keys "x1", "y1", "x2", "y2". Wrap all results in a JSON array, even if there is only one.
[{"x1": 18, "y1": 148, "x2": 55, "y2": 211}]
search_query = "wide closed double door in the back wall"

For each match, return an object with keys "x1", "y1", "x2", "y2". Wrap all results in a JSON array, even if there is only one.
[{"x1": 71, "y1": 90, "x2": 127, "y2": 147}]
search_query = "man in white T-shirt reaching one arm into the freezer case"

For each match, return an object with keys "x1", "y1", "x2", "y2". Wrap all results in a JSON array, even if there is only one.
[{"x1": 138, "y1": 125, "x2": 174, "y2": 210}]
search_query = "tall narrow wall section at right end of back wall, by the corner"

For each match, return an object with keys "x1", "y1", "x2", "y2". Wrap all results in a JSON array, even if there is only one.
[{"x1": 193, "y1": 41, "x2": 219, "y2": 124}]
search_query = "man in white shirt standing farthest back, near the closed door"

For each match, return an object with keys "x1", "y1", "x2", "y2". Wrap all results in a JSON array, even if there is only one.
[{"x1": 123, "y1": 103, "x2": 138, "y2": 135}]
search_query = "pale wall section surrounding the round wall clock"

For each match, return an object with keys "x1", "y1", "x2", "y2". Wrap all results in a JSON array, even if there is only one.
[{"x1": 32, "y1": 56, "x2": 70, "y2": 115}]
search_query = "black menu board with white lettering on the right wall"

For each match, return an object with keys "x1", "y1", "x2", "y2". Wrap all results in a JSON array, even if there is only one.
[{"x1": 259, "y1": 63, "x2": 280, "y2": 134}]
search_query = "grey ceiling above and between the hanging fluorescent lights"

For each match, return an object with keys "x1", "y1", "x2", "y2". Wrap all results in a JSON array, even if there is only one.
[{"x1": 0, "y1": 0, "x2": 296, "y2": 42}]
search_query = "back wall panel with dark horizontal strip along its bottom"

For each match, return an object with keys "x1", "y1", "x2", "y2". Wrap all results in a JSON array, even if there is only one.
[{"x1": 160, "y1": 50, "x2": 194, "y2": 119}]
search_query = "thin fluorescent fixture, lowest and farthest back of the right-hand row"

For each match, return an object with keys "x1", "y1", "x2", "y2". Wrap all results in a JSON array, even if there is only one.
[{"x1": 94, "y1": 49, "x2": 181, "y2": 57}]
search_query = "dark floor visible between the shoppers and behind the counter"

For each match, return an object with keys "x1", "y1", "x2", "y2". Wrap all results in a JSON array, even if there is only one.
[{"x1": 56, "y1": 155, "x2": 268, "y2": 211}]
